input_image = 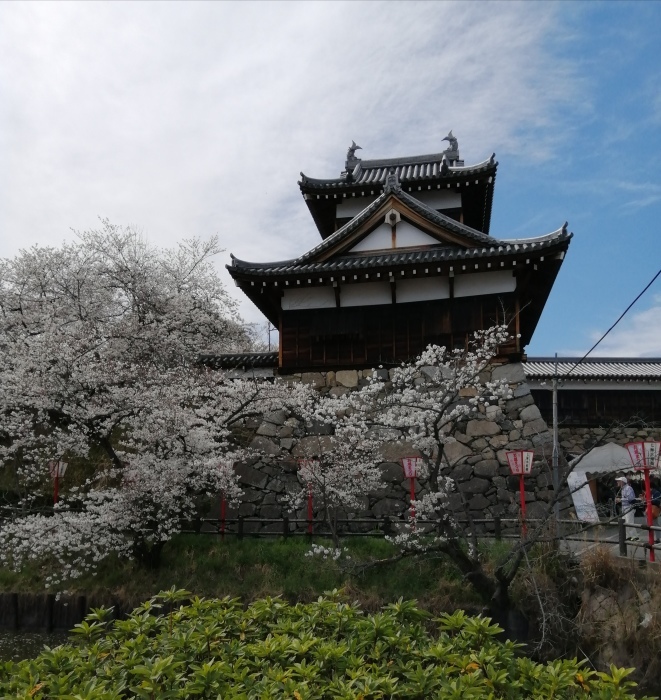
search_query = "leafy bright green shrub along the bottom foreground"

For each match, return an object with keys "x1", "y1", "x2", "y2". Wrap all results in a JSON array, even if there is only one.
[{"x1": 0, "y1": 589, "x2": 652, "y2": 700}]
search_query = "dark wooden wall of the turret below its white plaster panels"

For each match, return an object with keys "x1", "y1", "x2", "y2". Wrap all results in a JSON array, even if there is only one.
[{"x1": 280, "y1": 295, "x2": 516, "y2": 371}]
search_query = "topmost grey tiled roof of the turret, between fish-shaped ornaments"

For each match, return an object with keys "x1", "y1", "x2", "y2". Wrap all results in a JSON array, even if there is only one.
[{"x1": 299, "y1": 153, "x2": 498, "y2": 189}]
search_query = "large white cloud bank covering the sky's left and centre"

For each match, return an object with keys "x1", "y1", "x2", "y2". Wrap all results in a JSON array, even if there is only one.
[{"x1": 0, "y1": 2, "x2": 586, "y2": 319}]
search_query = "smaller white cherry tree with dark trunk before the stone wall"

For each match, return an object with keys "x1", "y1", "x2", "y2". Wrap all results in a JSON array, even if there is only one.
[{"x1": 324, "y1": 326, "x2": 516, "y2": 603}]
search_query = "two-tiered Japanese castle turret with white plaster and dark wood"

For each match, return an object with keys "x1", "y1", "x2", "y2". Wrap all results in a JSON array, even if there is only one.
[{"x1": 228, "y1": 132, "x2": 572, "y2": 374}]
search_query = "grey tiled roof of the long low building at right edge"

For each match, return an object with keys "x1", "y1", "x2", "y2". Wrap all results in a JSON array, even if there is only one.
[{"x1": 523, "y1": 357, "x2": 661, "y2": 380}]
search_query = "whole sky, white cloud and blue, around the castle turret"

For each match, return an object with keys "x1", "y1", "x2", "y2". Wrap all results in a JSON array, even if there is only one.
[{"x1": 0, "y1": 2, "x2": 661, "y2": 357}]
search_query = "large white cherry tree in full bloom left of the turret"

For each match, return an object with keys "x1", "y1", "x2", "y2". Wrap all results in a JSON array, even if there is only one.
[{"x1": 0, "y1": 221, "x2": 304, "y2": 583}]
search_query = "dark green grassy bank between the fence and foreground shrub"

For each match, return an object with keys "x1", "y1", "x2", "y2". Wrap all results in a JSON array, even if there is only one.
[{"x1": 0, "y1": 534, "x2": 479, "y2": 610}]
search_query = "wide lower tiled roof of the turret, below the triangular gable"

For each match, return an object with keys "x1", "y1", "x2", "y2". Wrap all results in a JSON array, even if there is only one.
[{"x1": 227, "y1": 226, "x2": 572, "y2": 276}]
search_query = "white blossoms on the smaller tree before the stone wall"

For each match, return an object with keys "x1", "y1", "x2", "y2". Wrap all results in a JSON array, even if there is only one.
[{"x1": 315, "y1": 326, "x2": 512, "y2": 550}]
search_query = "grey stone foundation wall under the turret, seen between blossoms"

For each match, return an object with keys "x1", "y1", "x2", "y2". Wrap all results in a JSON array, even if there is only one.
[{"x1": 217, "y1": 363, "x2": 570, "y2": 532}]
